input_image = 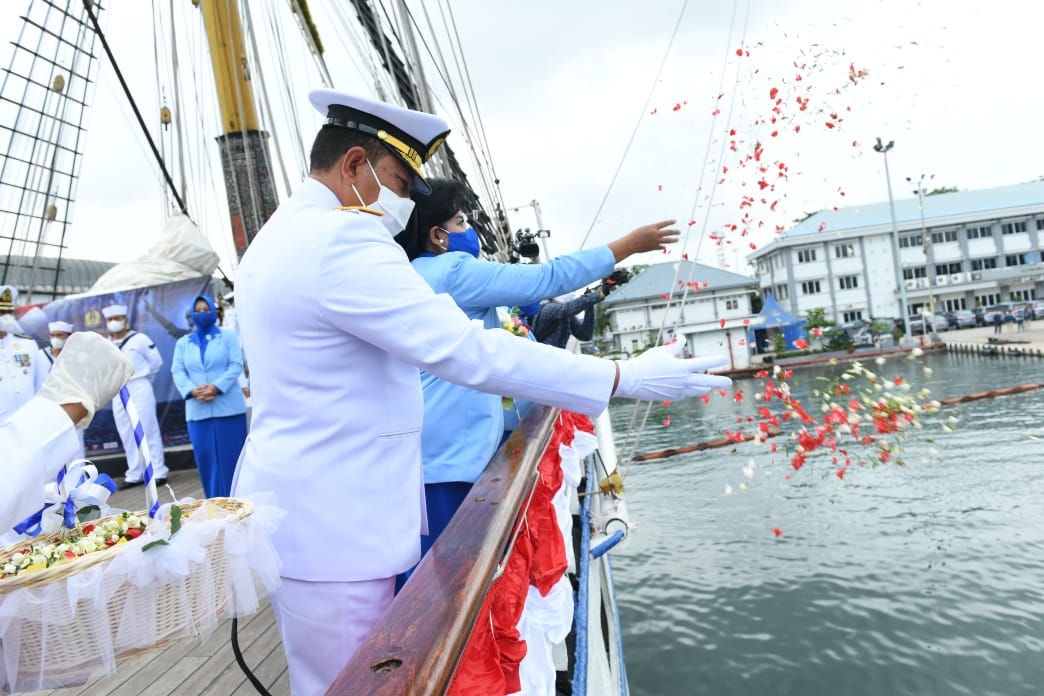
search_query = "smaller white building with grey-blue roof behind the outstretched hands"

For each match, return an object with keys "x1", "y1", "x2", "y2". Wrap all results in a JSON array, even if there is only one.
[{"x1": 601, "y1": 261, "x2": 761, "y2": 369}]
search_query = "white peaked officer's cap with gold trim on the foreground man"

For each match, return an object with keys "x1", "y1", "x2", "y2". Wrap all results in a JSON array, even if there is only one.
[{"x1": 308, "y1": 90, "x2": 450, "y2": 195}]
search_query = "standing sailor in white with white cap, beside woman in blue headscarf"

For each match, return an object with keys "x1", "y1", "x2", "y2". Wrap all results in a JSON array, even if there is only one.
[{"x1": 101, "y1": 305, "x2": 167, "y2": 488}]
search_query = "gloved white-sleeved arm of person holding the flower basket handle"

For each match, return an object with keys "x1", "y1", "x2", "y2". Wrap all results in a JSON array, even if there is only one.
[{"x1": 0, "y1": 332, "x2": 134, "y2": 530}]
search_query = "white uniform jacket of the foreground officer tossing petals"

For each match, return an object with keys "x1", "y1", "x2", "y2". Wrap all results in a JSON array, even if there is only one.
[{"x1": 233, "y1": 178, "x2": 615, "y2": 581}]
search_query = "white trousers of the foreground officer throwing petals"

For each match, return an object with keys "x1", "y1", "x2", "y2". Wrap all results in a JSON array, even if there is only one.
[{"x1": 271, "y1": 577, "x2": 395, "y2": 696}]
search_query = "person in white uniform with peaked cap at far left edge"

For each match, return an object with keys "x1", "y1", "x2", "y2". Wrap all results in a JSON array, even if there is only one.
[{"x1": 0, "y1": 285, "x2": 49, "y2": 419}]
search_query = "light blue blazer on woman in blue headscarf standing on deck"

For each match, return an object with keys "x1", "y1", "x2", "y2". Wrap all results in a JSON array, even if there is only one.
[{"x1": 170, "y1": 329, "x2": 246, "y2": 421}]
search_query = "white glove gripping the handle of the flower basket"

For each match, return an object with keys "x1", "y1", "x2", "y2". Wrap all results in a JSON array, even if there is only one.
[{"x1": 37, "y1": 331, "x2": 134, "y2": 430}]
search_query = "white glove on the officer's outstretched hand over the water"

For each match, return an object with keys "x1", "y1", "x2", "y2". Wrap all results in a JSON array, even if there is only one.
[{"x1": 613, "y1": 340, "x2": 732, "y2": 401}]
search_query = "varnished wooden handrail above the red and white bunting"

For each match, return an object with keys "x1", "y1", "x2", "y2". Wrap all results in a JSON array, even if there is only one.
[{"x1": 327, "y1": 404, "x2": 559, "y2": 696}]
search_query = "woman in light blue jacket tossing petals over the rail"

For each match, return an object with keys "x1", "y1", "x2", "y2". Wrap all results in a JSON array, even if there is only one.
[{"x1": 397, "y1": 178, "x2": 678, "y2": 567}]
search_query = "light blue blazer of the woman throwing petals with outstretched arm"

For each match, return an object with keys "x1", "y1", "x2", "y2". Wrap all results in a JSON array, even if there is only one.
[{"x1": 412, "y1": 246, "x2": 616, "y2": 483}]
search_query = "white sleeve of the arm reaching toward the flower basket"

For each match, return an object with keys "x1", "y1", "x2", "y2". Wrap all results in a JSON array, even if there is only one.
[{"x1": 0, "y1": 399, "x2": 80, "y2": 532}]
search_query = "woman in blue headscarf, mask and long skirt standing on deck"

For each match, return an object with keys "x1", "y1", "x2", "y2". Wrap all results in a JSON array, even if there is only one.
[{"x1": 170, "y1": 295, "x2": 246, "y2": 498}]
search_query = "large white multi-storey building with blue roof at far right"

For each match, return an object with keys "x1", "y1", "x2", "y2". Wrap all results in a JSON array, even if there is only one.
[{"x1": 749, "y1": 181, "x2": 1044, "y2": 322}]
